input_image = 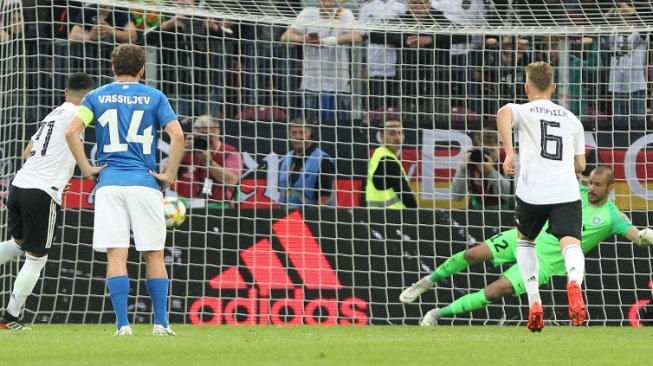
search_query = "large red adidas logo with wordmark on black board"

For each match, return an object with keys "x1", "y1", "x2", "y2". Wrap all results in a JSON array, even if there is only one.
[{"x1": 189, "y1": 211, "x2": 369, "y2": 325}]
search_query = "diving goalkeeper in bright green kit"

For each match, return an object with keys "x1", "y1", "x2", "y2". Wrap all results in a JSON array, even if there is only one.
[{"x1": 399, "y1": 166, "x2": 653, "y2": 326}]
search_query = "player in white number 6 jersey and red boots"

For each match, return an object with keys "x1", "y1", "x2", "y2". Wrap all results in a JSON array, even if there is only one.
[{"x1": 497, "y1": 62, "x2": 587, "y2": 332}]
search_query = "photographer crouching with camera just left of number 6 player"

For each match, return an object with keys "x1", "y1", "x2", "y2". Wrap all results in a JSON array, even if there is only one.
[{"x1": 451, "y1": 130, "x2": 514, "y2": 210}]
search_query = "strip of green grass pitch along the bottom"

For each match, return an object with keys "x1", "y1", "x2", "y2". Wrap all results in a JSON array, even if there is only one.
[{"x1": 0, "y1": 324, "x2": 653, "y2": 366}]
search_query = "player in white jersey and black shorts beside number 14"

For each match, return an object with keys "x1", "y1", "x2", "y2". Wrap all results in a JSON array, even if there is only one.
[{"x1": 0, "y1": 73, "x2": 95, "y2": 330}]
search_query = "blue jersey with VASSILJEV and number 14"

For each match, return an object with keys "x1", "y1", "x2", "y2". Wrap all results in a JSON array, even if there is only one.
[{"x1": 80, "y1": 82, "x2": 177, "y2": 190}]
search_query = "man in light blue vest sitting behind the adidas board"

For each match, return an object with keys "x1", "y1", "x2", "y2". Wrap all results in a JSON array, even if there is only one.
[{"x1": 279, "y1": 118, "x2": 335, "y2": 206}]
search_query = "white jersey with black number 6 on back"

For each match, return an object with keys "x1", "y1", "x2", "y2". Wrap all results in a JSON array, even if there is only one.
[{"x1": 507, "y1": 99, "x2": 585, "y2": 205}]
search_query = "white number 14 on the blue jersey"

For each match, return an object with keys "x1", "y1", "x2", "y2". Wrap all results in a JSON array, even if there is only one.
[{"x1": 97, "y1": 108, "x2": 154, "y2": 155}]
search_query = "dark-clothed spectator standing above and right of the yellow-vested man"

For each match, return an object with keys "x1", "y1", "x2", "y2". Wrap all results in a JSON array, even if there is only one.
[{"x1": 369, "y1": 0, "x2": 468, "y2": 121}]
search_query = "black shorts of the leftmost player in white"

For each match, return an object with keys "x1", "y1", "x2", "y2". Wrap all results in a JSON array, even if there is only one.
[{"x1": 7, "y1": 185, "x2": 61, "y2": 255}]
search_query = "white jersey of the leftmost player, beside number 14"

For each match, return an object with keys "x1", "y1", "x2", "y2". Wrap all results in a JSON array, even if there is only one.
[{"x1": 11, "y1": 102, "x2": 77, "y2": 204}]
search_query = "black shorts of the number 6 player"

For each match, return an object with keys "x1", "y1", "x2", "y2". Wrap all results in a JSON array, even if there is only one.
[{"x1": 515, "y1": 197, "x2": 583, "y2": 240}]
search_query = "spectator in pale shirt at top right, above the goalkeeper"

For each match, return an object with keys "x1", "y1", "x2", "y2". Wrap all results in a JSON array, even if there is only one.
[{"x1": 608, "y1": 1, "x2": 649, "y2": 129}]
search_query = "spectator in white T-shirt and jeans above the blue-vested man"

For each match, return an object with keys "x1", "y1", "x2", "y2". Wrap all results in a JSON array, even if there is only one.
[{"x1": 281, "y1": 0, "x2": 362, "y2": 125}]
